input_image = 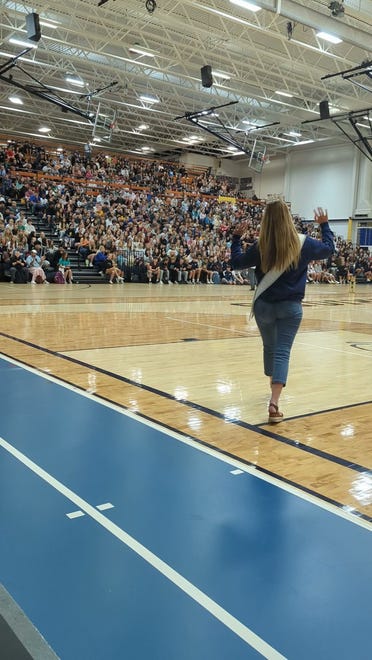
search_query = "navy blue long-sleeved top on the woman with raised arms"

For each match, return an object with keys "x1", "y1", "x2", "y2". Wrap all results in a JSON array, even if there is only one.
[{"x1": 231, "y1": 222, "x2": 335, "y2": 302}]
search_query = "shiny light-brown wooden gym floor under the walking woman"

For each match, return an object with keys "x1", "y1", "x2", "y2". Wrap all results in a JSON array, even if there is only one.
[{"x1": 0, "y1": 283, "x2": 372, "y2": 522}]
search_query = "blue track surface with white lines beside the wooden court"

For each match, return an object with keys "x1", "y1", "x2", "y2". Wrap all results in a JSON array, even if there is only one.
[{"x1": 0, "y1": 360, "x2": 372, "y2": 660}]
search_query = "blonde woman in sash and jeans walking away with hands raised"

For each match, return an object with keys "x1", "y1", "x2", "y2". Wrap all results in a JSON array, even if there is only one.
[{"x1": 231, "y1": 200, "x2": 335, "y2": 423}]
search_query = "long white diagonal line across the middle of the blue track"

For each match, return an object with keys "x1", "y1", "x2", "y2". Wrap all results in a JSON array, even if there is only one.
[{"x1": 0, "y1": 438, "x2": 285, "y2": 660}]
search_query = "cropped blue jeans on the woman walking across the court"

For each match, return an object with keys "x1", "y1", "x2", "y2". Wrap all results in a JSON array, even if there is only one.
[{"x1": 254, "y1": 298, "x2": 302, "y2": 385}]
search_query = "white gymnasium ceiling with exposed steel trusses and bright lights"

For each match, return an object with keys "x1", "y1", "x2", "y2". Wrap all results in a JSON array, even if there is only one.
[{"x1": 0, "y1": 0, "x2": 372, "y2": 160}]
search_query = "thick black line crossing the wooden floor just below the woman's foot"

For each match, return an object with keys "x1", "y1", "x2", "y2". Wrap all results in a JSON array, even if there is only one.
[{"x1": 0, "y1": 332, "x2": 370, "y2": 473}]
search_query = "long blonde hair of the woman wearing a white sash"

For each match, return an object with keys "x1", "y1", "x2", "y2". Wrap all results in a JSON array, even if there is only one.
[{"x1": 258, "y1": 199, "x2": 301, "y2": 273}]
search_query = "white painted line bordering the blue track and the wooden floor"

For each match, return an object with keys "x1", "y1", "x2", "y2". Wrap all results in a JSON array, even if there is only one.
[{"x1": 0, "y1": 353, "x2": 372, "y2": 531}]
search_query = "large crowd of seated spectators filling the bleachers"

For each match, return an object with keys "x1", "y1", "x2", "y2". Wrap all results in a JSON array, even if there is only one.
[{"x1": 0, "y1": 143, "x2": 372, "y2": 288}]
